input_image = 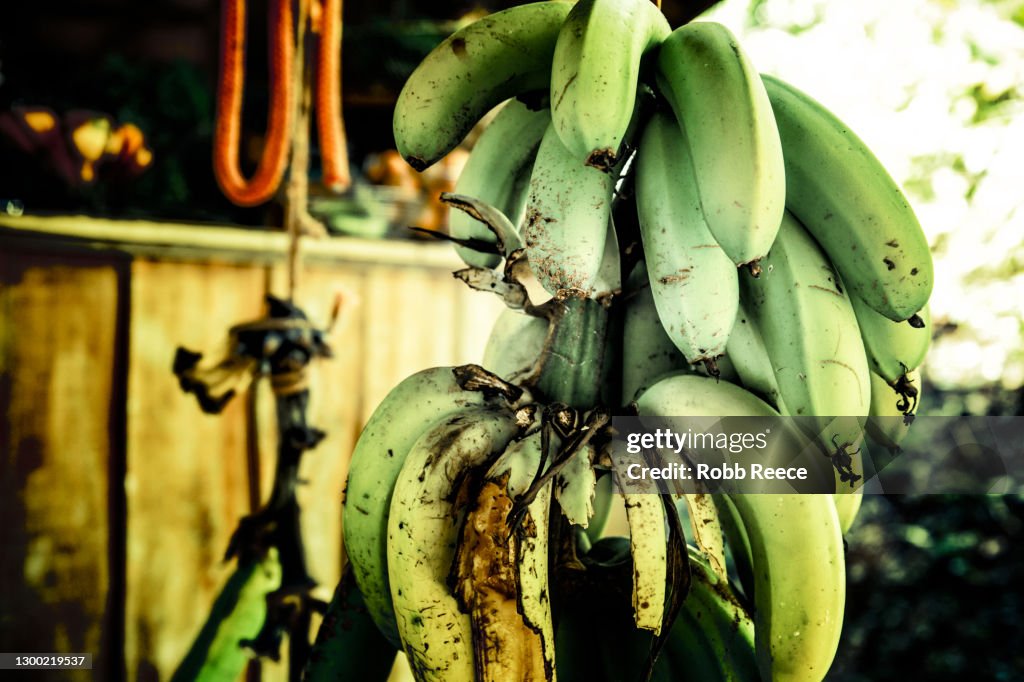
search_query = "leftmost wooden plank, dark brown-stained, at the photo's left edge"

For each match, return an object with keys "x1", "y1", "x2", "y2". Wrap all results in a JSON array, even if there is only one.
[{"x1": 0, "y1": 250, "x2": 125, "y2": 680}]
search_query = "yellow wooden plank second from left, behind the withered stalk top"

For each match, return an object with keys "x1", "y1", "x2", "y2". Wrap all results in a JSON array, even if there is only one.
[{"x1": 125, "y1": 260, "x2": 272, "y2": 681}]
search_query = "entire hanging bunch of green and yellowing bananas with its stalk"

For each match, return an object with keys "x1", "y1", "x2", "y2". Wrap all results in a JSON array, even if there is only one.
[{"x1": 321, "y1": 0, "x2": 933, "y2": 682}]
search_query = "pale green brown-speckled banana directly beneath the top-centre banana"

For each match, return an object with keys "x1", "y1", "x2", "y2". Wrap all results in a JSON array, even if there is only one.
[{"x1": 522, "y1": 124, "x2": 613, "y2": 296}]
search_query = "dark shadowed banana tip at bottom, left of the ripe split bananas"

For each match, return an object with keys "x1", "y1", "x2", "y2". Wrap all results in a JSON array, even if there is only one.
[{"x1": 302, "y1": 570, "x2": 397, "y2": 682}]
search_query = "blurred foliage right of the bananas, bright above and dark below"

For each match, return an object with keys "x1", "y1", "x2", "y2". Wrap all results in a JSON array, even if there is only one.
[{"x1": 711, "y1": 0, "x2": 1024, "y2": 682}]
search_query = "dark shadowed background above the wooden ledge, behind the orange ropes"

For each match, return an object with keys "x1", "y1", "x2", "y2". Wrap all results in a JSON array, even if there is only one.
[{"x1": 0, "y1": 0, "x2": 714, "y2": 220}]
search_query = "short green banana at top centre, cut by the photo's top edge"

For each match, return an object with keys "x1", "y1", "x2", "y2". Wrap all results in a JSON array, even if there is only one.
[{"x1": 551, "y1": 0, "x2": 671, "y2": 170}]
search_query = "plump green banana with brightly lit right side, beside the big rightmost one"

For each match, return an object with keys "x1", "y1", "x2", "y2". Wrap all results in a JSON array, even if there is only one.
[{"x1": 657, "y1": 22, "x2": 785, "y2": 265}]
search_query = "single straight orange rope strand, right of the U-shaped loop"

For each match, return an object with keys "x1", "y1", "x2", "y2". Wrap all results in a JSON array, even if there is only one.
[{"x1": 316, "y1": 0, "x2": 352, "y2": 191}]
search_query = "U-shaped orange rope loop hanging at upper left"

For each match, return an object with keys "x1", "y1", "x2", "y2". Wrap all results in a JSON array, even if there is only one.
[{"x1": 213, "y1": 0, "x2": 294, "y2": 206}]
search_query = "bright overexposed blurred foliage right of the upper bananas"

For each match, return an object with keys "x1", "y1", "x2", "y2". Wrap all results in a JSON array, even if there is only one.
[{"x1": 710, "y1": 0, "x2": 1024, "y2": 399}]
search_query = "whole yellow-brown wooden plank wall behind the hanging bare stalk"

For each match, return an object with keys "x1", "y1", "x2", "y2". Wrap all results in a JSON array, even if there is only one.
[{"x1": 0, "y1": 222, "x2": 500, "y2": 681}]
